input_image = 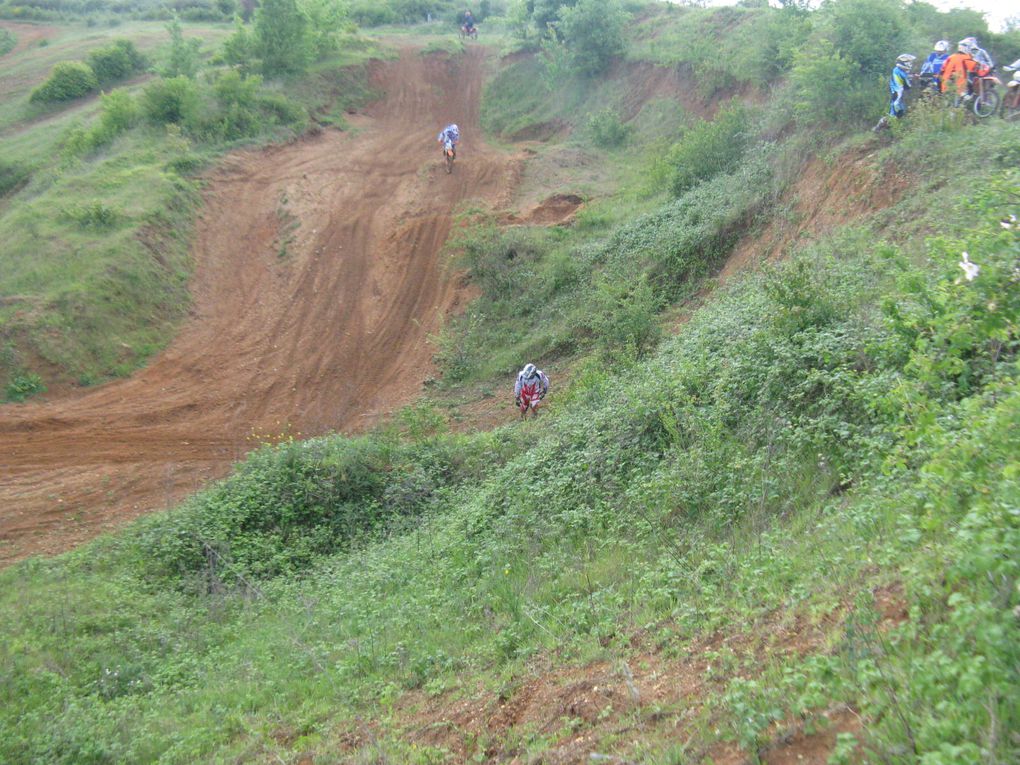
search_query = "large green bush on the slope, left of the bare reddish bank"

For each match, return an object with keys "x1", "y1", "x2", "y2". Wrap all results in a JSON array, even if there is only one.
[{"x1": 666, "y1": 100, "x2": 754, "y2": 196}]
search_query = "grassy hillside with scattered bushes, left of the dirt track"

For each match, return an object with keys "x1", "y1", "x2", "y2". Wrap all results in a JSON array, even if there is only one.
[{"x1": 0, "y1": 22, "x2": 375, "y2": 400}]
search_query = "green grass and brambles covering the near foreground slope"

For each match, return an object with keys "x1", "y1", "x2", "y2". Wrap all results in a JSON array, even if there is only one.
[{"x1": 0, "y1": 160, "x2": 1020, "y2": 763}]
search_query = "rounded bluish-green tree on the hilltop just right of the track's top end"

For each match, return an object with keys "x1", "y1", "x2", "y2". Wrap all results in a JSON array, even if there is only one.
[{"x1": 557, "y1": 0, "x2": 629, "y2": 75}]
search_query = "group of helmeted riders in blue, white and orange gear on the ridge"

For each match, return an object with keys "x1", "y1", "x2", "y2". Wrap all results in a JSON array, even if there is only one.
[{"x1": 889, "y1": 37, "x2": 1020, "y2": 117}]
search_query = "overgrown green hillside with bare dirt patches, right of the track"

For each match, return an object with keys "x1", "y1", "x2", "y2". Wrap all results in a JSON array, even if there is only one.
[{"x1": 0, "y1": 0, "x2": 1020, "y2": 765}]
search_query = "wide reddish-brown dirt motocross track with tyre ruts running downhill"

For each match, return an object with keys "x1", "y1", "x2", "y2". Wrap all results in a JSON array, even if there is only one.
[{"x1": 0, "y1": 48, "x2": 518, "y2": 563}]
